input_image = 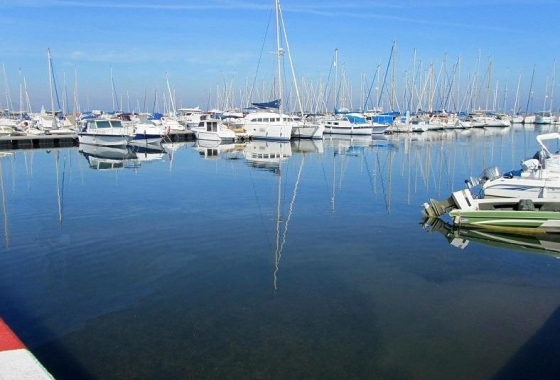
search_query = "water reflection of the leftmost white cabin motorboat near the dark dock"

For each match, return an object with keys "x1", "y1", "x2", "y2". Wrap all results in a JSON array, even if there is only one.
[{"x1": 78, "y1": 144, "x2": 140, "y2": 170}]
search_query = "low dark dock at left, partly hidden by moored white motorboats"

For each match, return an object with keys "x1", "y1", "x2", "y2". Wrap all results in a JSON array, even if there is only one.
[{"x1": 0, "y1": 131, "x2": 194, "y2": 151}]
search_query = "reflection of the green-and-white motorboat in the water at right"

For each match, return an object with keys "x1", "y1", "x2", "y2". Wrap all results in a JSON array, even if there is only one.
[{"x1": 421, "y1": 218, "x2": 560, "y2": 258}]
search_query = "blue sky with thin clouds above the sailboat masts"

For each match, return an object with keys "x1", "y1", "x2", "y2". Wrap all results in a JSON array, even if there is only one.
[{"x1": 0, "y1": 0, "x2": 560, "y2": 111}]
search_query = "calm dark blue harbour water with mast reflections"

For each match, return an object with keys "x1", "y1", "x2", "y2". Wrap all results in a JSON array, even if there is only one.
[{"x1": 0, "y1": 126, "x2": 560, "y2": 379}]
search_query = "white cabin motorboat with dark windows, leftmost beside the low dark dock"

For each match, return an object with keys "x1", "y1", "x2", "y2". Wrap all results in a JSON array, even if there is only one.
[{"x1": 78, "y1": 119, "x2": 134, "y2": 146}]
